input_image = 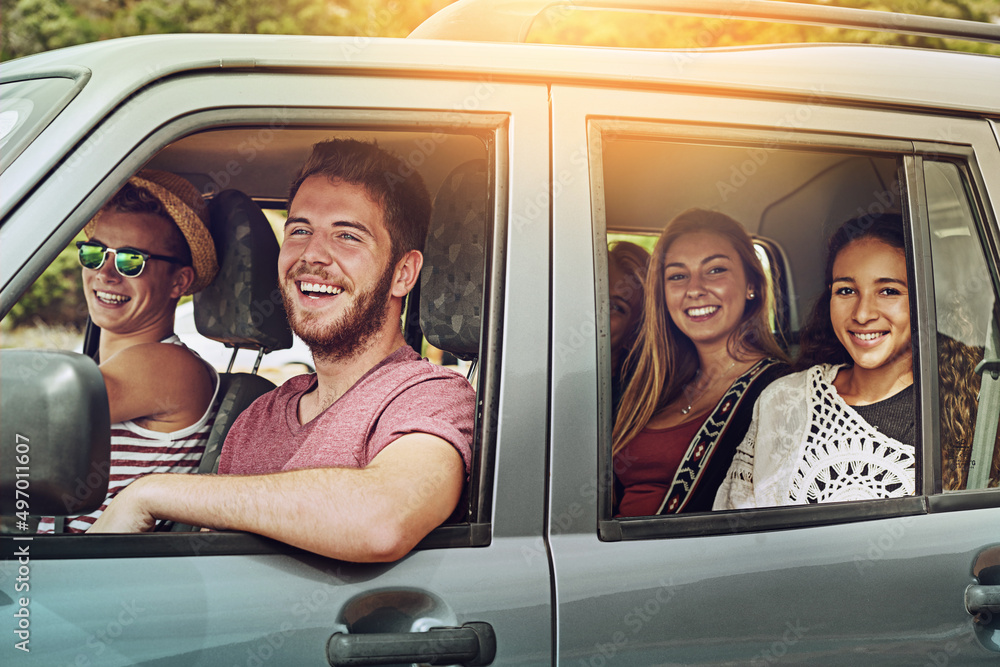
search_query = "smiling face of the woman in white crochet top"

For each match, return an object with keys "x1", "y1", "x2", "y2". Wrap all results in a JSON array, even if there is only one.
[{"x1": 830, "y1": 238, "x2": 913, "y2": 375}]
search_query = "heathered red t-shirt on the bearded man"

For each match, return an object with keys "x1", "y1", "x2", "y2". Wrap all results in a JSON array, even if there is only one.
[{"x1": 219, "y1": 346, "x2": 476, "y2": 475}]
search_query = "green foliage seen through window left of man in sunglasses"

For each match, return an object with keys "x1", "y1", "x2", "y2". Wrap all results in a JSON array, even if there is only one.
[{"x1": 4, "y1": 244, "x2": 87, "y2": 328}]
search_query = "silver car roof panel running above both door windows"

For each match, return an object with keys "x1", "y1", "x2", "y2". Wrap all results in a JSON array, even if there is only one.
[{"x1": 2, "y1": 34, "x2": 1000, "y2": 114}]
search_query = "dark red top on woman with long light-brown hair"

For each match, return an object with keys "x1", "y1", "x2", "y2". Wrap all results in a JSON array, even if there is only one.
[{"x1": 614, "y1": 411, "x2": 708, "y2": 516}]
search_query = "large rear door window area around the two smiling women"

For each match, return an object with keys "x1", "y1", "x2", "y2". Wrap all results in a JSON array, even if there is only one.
[{"x1": 595, "y1": 129, "x2": 928, "y2": 539}]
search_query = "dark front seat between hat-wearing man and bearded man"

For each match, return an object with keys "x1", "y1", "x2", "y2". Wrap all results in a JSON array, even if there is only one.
[{"x1": 167, "y1": 190, "x2": 292, "y2": 531}]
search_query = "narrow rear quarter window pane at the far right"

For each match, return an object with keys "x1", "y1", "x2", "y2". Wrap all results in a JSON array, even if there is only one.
[{"x1": 924, "y1": 161, "x2": 1000, "y2": 491}]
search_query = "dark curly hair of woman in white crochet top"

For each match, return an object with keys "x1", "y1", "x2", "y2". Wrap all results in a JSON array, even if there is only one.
[{"x1": 795, "y1": 213, "x2": 906, "y2": 370}]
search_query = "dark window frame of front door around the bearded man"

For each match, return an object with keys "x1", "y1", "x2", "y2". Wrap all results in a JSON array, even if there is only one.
[{"x1": 0, "y1": 105, "x2": 510, "y2": 560}]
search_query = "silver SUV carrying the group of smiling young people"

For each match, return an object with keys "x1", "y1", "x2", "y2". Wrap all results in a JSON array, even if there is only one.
[{"x1": 0, "y1": 0, "x2": 1000, "y2": 667}]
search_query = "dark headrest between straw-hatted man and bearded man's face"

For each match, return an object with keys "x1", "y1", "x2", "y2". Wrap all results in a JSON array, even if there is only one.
[{"x1": 194, "y1": 190, "x2": 292, "y2": 351}]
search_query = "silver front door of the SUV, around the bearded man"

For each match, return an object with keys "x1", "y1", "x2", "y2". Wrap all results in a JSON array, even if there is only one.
[{"x1": 0, "y1": 42, "x2": 552, "y2": 666}]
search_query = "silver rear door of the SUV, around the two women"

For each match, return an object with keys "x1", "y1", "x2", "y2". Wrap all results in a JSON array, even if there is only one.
[{"x1": 548, "y1": 74, "x2": 1000, "y2": 667}]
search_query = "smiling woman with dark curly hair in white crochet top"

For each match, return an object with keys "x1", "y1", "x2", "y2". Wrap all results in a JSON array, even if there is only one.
[{"x1": 715, "y1": 214, "x2": 916, "y2": 509}]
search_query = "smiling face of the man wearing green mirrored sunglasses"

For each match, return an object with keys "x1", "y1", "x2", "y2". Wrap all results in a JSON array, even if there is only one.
[{"x1": 81, "y1": 210, "x2": 194, "y2": 335}]
